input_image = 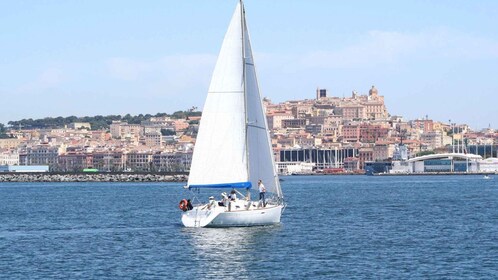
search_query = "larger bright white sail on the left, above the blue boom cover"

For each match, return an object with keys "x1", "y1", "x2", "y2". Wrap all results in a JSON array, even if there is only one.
[{"x1": 188, "y1": 3, "x2": 249, "y2": 186}]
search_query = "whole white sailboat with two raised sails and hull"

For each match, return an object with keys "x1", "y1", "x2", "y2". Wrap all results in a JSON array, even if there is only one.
[{"x1": 180, "y1": 1, "x2": 285, "y2": 227}]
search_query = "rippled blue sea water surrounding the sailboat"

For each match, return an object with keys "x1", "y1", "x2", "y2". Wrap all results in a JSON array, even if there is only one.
[{"x1": 0, "y1": 176, "x2": 498, "y2": 279}]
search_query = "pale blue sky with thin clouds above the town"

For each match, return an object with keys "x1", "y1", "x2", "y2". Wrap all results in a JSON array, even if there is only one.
[{"x1": 0, "y1": 0, "x2": 498, "y2": 129}]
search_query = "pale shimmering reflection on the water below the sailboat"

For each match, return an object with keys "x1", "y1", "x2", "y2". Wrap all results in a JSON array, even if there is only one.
[{"x1": 182, "y1": 225, "x2": 282, "y2": 279}]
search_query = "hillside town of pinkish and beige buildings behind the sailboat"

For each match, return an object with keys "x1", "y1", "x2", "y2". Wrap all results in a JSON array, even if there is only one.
[{"x1": 0, "y1": 86, "x2": 498, "y2": 174}]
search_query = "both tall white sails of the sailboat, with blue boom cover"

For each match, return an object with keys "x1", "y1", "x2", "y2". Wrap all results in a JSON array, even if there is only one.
[{"x1": 188, "y1": 2, "x2": 282, "y2": 198}]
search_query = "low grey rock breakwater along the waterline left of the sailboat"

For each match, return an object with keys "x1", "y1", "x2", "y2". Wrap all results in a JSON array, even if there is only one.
[{"x1": 0, "y1": 173, "x2": 188, "y2": 182}]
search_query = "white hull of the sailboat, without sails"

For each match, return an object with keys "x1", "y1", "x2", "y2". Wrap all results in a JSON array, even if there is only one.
[{"x1": 182, "y1": 202, "x2": 283, "y2": 227}]
